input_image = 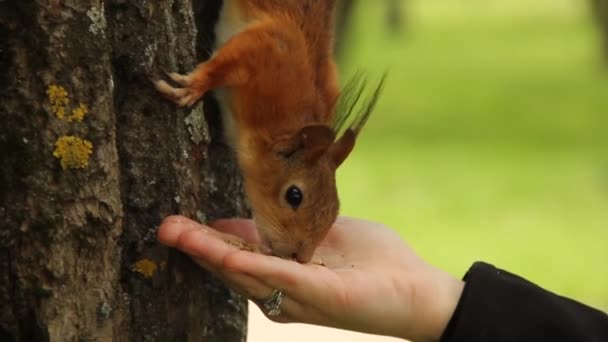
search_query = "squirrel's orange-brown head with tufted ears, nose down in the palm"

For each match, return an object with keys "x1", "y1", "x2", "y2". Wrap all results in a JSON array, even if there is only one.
[{"x1": 241, "y1": 75, "x2": 384, "y2": 263}]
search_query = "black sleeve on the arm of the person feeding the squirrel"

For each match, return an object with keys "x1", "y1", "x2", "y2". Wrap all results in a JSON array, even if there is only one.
[{"x1": 441, "y1": 262, "x2": 608, "y2": 342}]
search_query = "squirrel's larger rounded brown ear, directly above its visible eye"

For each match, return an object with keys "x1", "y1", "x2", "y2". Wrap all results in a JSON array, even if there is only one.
[{"x1": 275, "y1": 125, "x2": 336, "y2": 163}]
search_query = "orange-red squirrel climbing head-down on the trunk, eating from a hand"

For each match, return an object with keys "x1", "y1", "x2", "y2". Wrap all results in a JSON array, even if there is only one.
[{"x1": 155, "y1": 0, "x2": 384, "y2": 263}]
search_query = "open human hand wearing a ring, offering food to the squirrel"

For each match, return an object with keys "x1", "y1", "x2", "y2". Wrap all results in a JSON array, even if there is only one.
[{"x1": 158, "y1": 216, "x2": 464, "y2": 341}]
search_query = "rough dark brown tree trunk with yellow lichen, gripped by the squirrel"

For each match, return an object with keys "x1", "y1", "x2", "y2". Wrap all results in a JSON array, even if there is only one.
[{"x1": 0, "y1": 0, "x2": 247, "y2": 341}]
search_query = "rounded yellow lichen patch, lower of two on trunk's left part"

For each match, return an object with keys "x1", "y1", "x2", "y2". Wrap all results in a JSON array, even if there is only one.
[{"x1": 53, "y1": 136, "x2": 93, "y2": 170}]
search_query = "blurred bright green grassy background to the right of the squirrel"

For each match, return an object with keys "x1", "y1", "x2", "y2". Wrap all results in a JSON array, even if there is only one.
[{"x1": 338, "y1": 0, "x2": 608, "y2": 310}]
